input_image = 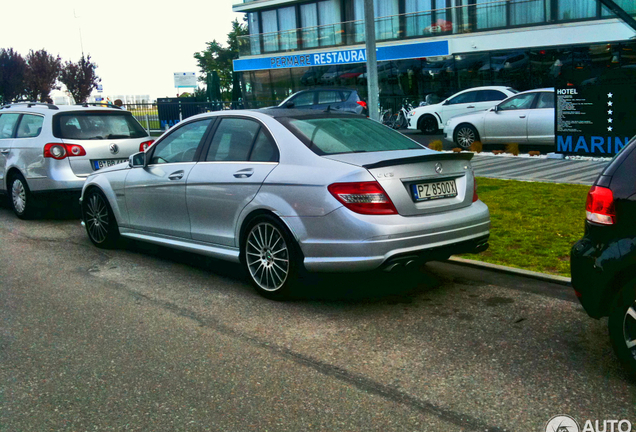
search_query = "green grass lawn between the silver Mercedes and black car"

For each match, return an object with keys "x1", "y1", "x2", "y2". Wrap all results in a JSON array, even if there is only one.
[{"x1": 464, "y1": 177, "x2": 590, "y2": 276}]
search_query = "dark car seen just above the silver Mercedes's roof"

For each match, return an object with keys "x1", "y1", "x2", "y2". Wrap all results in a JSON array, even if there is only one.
[{"x1": 278, "y1": 88, "x2": 368, "y2": 115}]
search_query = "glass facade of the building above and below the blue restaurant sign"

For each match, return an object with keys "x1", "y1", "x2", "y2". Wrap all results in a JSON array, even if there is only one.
[{"x1": 235, "y1": 0, "x2": 636, "y2": 107}]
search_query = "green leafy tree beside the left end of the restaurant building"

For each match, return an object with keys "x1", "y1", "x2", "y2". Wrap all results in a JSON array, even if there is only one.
[{"x1": 194, "y1": 19, "x2": 247, "y2": 100}]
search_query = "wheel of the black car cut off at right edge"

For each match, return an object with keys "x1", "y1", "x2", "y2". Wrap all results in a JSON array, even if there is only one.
[{"x1": 608, "y1": 282, "x2": 636, "y2": 378}]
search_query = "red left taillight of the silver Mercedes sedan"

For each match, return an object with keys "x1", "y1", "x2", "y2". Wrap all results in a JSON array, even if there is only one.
[{"x1": 327, "y1": 181, "x2": 397, "y2": 215}]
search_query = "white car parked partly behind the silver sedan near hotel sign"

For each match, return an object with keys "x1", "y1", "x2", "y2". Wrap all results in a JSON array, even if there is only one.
[{"x1": 408, "y1": 86, "x2": 517, "y2": 134}]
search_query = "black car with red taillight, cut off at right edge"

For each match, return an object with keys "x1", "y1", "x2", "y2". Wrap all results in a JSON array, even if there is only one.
[{"x1": 570, "y1": 138, "x2": 636, "y2": 375}]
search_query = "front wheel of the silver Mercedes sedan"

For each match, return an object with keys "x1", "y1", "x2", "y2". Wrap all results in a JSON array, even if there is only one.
[{"x1": 82, "y1": 188, "x2": 120, "y2": 249}]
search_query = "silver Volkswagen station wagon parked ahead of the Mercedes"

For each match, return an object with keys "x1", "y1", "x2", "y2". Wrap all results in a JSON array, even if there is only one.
[{"x1": 0, "y1": 103, "x2": 153, "y2": 219}]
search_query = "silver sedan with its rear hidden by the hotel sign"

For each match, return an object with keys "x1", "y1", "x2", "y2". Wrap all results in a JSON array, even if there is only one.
[{"x1": 444, "y1": 89, "x2": 555, "y2": 148}]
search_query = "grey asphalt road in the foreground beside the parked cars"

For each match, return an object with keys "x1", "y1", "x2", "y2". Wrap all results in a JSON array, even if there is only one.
[{"x1": 0, "y1": 203, "x2": 636, "y2": 432}]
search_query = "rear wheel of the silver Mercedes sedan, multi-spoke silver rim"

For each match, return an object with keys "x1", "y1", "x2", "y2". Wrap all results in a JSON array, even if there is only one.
[{"x1": 241, "y1": 215, "x2": 301, "y2": 300}]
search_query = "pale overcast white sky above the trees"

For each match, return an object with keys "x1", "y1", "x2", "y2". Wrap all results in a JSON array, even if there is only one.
[{"x1": 0, "y1": 0, "x2": 244, "y2": 99}]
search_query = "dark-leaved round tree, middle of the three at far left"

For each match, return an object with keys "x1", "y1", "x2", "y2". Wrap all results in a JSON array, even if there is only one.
[{"x1": 26, "y1": 49, "x2": 62, "y2": 102}]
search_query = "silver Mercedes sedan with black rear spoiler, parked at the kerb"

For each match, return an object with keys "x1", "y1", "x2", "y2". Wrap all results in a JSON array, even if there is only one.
[{"x1": 80, "y1": 109, "x2": 490, "y2": 299}]
